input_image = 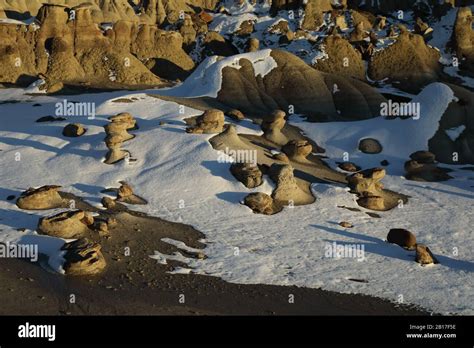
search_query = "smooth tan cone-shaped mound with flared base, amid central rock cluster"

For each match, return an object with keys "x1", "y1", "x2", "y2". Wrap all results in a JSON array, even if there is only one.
[{"x1": 269, "y1": 164, "x2": 315, "y2": 206}]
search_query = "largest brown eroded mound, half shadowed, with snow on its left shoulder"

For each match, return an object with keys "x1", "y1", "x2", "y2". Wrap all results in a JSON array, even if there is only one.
[{"x1": 217, "y1": 50, "x2": 385, "y2": 120}]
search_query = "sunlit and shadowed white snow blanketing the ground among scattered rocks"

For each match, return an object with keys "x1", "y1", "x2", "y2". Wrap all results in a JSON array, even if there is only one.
[{"x1": 0, "y1": 83, "x2": 474, "y2": 314}]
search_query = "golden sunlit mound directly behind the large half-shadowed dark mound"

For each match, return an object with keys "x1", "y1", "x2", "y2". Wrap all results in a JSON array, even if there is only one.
[{"x1": 313, "y1": 35, "x2": 365, "y2": 80}]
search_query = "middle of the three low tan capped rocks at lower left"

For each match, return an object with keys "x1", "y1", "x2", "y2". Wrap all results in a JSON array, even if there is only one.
[{"x1": 38, "y1": 210, "x2": 94, "y2": 239}]
